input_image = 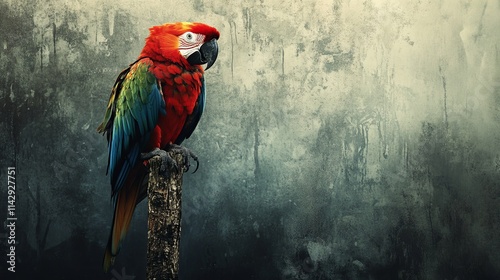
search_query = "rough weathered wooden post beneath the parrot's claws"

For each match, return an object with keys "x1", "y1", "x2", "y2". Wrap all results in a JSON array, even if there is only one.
[{"x1": 146, "y1": 152, "x2": 184, "y2": 280}]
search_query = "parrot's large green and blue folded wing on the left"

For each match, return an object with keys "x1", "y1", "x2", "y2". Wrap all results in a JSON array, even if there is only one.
[{"x1": 97, "y1": 58, "x2": 166, "y2": 198}]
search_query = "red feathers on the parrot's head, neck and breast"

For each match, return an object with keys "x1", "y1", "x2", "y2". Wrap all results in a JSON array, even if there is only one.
[{"x1": 139, "y1": 22, "x2": 220, "y2": 149}]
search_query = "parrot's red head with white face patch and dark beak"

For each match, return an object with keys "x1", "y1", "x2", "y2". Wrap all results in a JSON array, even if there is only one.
[{"x1": 140, "y1": 22, "x2": 220, "y2": 70}]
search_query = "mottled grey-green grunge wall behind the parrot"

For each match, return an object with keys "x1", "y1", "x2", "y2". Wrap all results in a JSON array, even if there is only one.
[{"x1": 0, "y1": 0, "x2": 500, "y2": 279}]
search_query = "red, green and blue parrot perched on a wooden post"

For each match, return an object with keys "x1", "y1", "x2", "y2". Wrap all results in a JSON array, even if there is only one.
[{"x1": 97, "y1": 22, "x2": 220, "y2": 272}]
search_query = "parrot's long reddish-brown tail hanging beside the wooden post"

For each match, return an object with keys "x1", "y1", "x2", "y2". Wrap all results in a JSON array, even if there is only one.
[{"x1": 103, "y1": 164, "x2": 146, "y2": 272}]
